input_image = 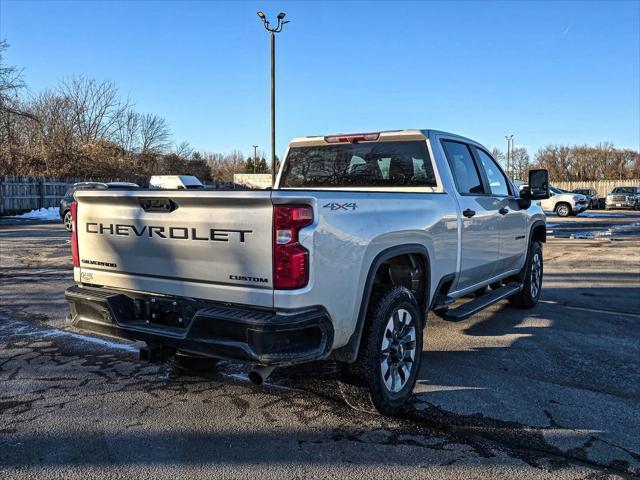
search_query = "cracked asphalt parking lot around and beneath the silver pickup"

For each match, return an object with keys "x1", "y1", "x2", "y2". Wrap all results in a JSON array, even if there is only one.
[{"x1": 0, "y1": 215, "x2": 640, "y2": 479}]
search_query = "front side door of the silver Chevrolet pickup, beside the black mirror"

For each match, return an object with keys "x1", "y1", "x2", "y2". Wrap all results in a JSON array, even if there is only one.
[{"x1": 472, "y1": 147, "x2": 527, "y2": 276}]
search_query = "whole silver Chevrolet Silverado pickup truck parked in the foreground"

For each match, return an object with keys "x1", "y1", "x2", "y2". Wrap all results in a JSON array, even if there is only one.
[{"x1": 66, "y1": 130, "x2": 549, "y2": 414}]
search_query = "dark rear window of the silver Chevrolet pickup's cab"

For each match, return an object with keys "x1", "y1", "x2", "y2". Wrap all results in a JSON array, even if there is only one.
[{"x1": 280, "y1": 140, "x2": 436, "y2": 189}]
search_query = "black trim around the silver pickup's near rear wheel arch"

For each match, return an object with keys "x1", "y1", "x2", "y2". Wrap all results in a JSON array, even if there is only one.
[{"x1": 329, "y1": 243, "x2": 431, "y2": 363}]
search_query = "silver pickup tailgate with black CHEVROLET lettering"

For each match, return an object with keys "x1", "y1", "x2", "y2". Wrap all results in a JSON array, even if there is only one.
[{"x1": 75, "y1": 190, "x2": 273, "y2": 307}]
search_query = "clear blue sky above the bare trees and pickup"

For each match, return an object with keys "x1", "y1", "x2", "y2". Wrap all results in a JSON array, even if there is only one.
[{"x1": 0, "y1": 0, "x2": 640, "y2": 155}]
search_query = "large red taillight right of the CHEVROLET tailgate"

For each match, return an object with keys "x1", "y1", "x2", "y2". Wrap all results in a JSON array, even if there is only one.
[{"x1": 273, "y1": 205, "x2": 313, "y2": 290}]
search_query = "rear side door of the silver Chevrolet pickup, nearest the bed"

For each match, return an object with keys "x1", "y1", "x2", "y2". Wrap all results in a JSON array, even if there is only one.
[{"x1": 441, "y1": 139, "x2": 502, "y2": 290}]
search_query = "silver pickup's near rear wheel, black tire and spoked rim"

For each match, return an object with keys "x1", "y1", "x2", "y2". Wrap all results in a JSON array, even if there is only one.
[{"x1": 338, "y1": 287, "x2": 424, "y2": 415}]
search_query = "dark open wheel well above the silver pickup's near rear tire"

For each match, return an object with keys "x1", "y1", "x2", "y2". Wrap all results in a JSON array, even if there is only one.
[{"x1": 373, "y1": 253, "x2": 428, "y2": 309}]
